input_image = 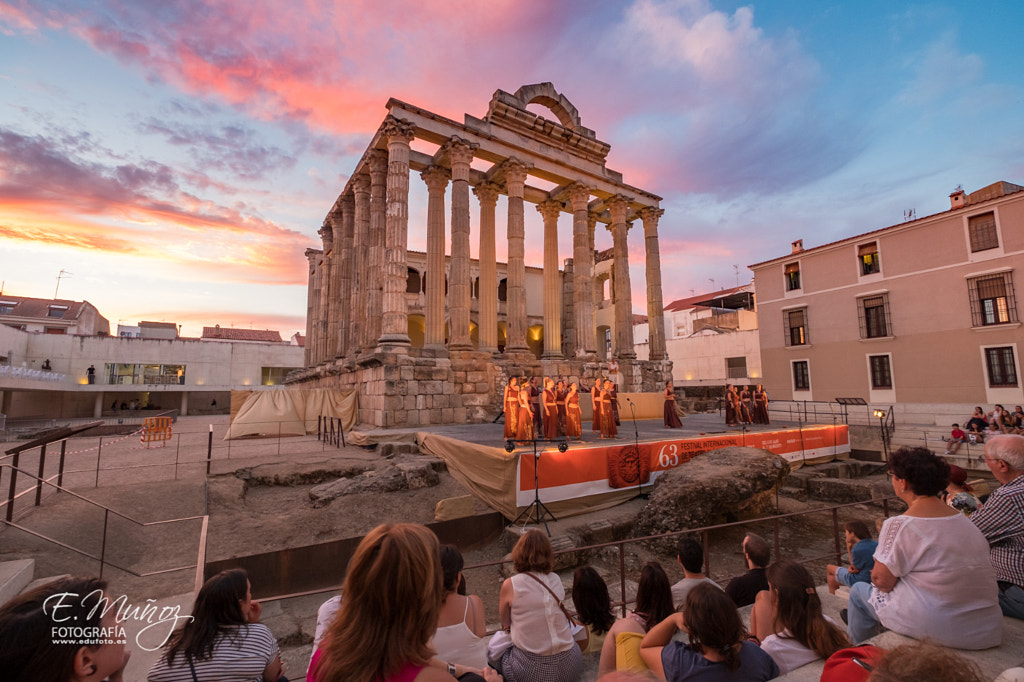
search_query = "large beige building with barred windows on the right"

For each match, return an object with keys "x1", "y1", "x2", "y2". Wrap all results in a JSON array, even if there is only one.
[{"x1": 751, "y1": 182, "x2": 1024, "y2": 424}]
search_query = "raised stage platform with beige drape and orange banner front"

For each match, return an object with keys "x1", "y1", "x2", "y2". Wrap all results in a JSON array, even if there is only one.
[{"x1": 351, "y1": 415, "x2": 850, "y2": 518}]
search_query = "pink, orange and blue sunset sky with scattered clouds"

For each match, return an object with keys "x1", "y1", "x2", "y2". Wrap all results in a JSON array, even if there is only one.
[{"x1": 0, "y1": 0, "x2": 1024, "y2": 338}]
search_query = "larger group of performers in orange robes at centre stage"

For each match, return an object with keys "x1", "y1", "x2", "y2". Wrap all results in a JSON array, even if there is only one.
[{"x1": 502, "y1": 377, "x2": 620, "y2": 440}]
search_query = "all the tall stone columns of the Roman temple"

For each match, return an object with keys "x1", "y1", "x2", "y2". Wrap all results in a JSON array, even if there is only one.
[{"x1": 306, "y1": 119, "x2": 665, "y2": 365}]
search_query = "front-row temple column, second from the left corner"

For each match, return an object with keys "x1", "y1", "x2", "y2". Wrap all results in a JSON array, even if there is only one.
[{"x1": 444, "y1": 137, "x2": 476, "y2": 350}]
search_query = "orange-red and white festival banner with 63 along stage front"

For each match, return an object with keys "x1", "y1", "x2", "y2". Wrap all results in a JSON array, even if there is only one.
[{"x1": 516, "y1": 424, "x2": 850, "y2": 507}]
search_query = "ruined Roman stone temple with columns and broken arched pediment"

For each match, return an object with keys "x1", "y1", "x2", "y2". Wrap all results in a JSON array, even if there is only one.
[{"x1": 294, "y1": 83, "x2": 671, "y2": 426}]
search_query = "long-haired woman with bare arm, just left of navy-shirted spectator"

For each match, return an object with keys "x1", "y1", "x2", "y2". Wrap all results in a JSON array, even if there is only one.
[{"x1": 598, "y1": 561, "x2": 676, "y2": 677}]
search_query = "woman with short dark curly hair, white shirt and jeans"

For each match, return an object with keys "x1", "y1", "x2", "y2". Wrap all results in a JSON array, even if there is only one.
[{"x1": 848, "y1": 447, "x2": 1002, "y2": 649}]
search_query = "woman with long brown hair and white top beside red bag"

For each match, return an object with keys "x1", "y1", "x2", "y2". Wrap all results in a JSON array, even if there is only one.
[{"x1": 751, "y1": 557, "x2": 851, "y2": 675}]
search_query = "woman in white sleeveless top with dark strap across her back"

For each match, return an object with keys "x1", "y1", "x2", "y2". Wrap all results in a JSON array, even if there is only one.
[{"x1": 498, "y1": 530, "x2": 588, "y2": 682}]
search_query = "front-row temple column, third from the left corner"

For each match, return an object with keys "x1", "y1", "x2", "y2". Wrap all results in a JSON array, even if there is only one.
[{"x1": 502, "y1": 157, "x2": 529, "y2": 352}]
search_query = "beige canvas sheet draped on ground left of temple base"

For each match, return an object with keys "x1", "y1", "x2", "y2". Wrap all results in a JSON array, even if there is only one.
[{"x1": 224, "y1": 388, "x2": 358, "y2": 440}]
